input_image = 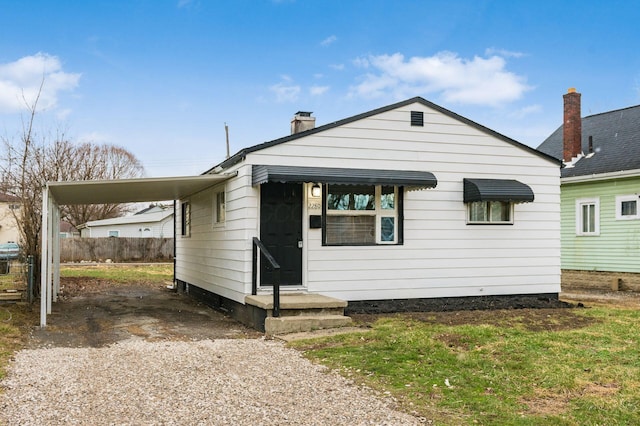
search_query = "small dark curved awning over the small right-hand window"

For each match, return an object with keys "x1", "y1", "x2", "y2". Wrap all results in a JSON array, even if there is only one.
[{"x1": 464, "y1": 179, "x2": 534, "y2": 203}]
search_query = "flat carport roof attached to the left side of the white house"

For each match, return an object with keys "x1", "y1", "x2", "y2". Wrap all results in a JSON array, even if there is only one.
[{"x1": 47, "y1": 174, "x2": 233, "y2": 205}]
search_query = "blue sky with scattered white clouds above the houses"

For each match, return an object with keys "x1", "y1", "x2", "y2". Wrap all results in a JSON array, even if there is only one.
[{"x1": 0, "y1": 0, "x2": 640, "y2": 177}]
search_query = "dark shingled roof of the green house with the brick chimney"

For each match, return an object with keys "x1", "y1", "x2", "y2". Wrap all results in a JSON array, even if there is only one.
[{"x1": 538, "y1": 105, "x2": 640, "y2": 178}]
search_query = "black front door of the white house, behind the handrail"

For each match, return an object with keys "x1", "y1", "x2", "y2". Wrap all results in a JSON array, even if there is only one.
[{"x1": 260, "y1": 182, "x2": 302, "y2": 286}]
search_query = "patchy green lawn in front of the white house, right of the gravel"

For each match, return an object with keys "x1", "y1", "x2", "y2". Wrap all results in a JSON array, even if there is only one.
[{"x1": 292, "y1": 307, "x2": 640, "y2": 425}]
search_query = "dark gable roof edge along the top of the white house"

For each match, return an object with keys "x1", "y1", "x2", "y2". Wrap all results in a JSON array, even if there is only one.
[{"x1": 210, "y1": 96, "x2": 562, "y2": 174}]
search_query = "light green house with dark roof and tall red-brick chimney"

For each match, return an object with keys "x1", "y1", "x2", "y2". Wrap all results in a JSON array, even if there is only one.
[{"x1": 538, "y1": 89, "x2": 640, "y2": 288}]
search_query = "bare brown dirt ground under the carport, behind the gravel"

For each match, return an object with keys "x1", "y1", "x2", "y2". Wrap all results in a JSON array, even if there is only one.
[{"x1": 29, "y1": 278, "x2": 261, "y2": 348}]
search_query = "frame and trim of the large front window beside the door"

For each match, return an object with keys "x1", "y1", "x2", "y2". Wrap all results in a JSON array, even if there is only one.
[{"x1": 322, "y1": 184, "x2": 404, "y2": 247}]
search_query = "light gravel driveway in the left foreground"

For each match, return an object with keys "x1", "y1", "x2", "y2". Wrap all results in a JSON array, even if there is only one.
[{"x1": 0, "y1": 284, "x2": 420, "y2": 425}]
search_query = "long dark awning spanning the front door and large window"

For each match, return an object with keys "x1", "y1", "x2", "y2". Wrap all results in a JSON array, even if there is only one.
[{"x1": 252, "y1": 165, "x2": 438, "y2": 190}]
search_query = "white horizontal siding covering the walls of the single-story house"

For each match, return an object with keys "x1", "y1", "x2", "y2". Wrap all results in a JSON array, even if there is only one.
[{"x1": 177, "y1": 104, "x2": 560, "y2": 302}]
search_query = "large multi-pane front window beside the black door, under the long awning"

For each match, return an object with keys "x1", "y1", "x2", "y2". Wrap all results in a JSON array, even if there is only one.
[{"x1": 324, "y1": 185, "x2": 400, "y2": 245}]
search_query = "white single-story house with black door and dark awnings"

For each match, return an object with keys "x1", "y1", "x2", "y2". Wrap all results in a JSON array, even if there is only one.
[{"x1": 175, "y1": 97, "x2": 561, "y2": 328}]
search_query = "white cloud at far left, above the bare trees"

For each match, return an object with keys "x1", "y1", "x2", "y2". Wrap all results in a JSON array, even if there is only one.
[{"x1": 0, "y1": 53, "x2": 80, "y2": 113}]
